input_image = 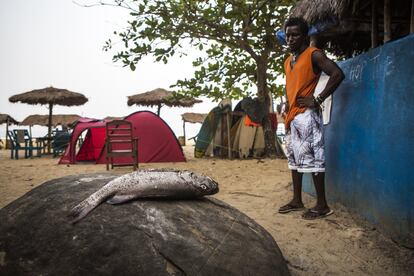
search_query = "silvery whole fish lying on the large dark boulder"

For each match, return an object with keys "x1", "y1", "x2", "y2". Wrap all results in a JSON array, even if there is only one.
[{"x1": 69, "y1": 169, "x2": 219, "y2": 224}]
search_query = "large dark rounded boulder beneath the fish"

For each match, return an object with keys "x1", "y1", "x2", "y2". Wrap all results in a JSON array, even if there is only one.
[{"x1": 0, "y1": 174, "x2": 289, "y2": 276}]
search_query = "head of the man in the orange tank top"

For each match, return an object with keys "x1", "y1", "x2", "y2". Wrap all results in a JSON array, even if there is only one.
[{"x1": 285, "y1": 17, "x2": 309, "y2": 52}]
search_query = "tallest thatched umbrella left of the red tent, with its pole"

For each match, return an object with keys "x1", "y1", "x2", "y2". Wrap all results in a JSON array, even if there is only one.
[{"x1": 9, "y1": 86, "x2": 88, "y2": 152}]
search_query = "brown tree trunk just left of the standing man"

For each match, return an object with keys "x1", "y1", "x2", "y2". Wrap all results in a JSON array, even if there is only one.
[{"x1": 257, "y1": 60, "x2": 278, "y2": 158}]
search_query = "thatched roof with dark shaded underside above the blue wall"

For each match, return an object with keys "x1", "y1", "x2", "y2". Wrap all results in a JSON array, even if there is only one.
[{"x1": 291, "y1": 0, "x2": 411, "y2": 57}]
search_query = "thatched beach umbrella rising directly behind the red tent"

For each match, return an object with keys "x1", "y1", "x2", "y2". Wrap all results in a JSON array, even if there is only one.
[{"x1": 128, "y1": 88, "x2": 202, "y2": 116}]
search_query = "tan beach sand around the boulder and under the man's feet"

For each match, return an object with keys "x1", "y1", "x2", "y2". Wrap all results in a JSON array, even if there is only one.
[{"x1": 0, "y1": 146, "x2": 414, "y2": 275}]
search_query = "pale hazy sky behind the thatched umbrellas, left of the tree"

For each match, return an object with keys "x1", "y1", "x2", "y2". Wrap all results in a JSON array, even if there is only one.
[{"x1": 0, "y1": 0, "x2": 217, "y2": 138}]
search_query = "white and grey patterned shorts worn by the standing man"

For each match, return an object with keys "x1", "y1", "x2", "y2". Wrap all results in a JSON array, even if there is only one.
[{"x1": 286, "y1": 109, "x2": 325, "y2": 173}]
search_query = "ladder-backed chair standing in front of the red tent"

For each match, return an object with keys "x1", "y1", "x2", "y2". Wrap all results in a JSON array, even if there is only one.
[{"x1": 105, "y1": 120, "x2": 138, "y2": 171}]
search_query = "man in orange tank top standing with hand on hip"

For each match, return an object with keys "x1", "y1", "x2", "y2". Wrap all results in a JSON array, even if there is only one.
[{"x1": 279, "y1": 17, "x2": 344, "y2": 219}]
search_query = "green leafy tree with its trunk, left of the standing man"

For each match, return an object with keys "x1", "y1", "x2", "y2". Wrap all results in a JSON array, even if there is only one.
[{"x1": 91, "y1": 0, "x2": 295, "y2": 156}]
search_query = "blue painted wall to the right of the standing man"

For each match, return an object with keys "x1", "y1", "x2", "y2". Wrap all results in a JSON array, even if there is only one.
[{"x1": 304, "y1": 35, "x2": 414, "y2": 247}]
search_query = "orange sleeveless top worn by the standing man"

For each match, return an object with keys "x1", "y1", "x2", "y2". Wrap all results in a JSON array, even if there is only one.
[{"x1": 285, "y1": 47, "x2": 320, "y2": 129}]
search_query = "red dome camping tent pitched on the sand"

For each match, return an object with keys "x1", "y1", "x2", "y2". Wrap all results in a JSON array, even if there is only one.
[{"x1": 59, "y1": 111, "x2": 186, "y2": 164}]
